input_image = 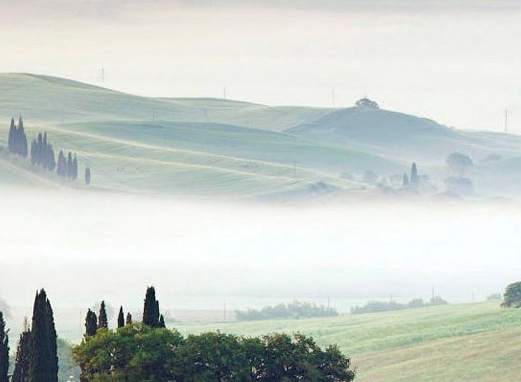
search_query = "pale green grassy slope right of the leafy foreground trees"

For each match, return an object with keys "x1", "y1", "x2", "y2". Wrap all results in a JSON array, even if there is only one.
[{"x1": 173, "y1": 302, "x2": 521, "y2": 382}]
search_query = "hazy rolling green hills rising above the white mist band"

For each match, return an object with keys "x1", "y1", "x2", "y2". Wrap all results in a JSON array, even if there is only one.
[{"x1": 0, "y1": 74, "x2": 521, "y2": 199}]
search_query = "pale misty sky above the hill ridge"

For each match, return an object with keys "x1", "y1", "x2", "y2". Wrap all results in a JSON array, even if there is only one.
[{"x1": 0, "y1": 0, "x2": 521, "y2": 133}]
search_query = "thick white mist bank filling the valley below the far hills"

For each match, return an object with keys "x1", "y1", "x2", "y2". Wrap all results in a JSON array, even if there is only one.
[{"x1": 0, "y1": 189, "x2": 521, "y2": 338}]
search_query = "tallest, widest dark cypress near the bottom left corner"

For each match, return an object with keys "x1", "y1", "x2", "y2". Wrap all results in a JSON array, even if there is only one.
[{"x1": 28, "y1": 288, "x2": 58, "y2": 382}]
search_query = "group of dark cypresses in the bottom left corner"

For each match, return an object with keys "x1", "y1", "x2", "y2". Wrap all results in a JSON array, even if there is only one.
[{"x1": 0, "y1": 289, "x2": 58, "y2": 382}]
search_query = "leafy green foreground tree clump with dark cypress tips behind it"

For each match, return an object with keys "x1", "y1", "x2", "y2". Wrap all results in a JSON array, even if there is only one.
[{"x1": 72, "y1": 287, "x2": 355, "y2": 382}]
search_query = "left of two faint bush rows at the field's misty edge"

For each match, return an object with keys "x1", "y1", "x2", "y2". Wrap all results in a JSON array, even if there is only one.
[{"x1": 235, "y1": 301, "x2": 338, "y2": 321}]
